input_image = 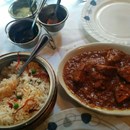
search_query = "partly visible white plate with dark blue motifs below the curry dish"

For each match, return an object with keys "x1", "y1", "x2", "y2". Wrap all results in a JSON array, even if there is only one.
[{"x1": 36, "y1": 108, "x2": 130, "y2": 130}]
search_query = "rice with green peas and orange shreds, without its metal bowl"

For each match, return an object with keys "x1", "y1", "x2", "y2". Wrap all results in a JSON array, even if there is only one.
[{"x1": 0, "y1": 61, "x2": 50, "y2": 126}]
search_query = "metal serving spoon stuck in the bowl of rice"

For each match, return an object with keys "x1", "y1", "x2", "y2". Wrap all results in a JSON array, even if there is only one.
[{"x1": 18, "y1": 34, "x2": 50, "y2": 77}]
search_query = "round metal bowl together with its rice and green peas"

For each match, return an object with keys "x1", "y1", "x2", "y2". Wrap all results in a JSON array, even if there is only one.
[{"x1": 0, "y1": 52, "x2": 57, "y2": 130}]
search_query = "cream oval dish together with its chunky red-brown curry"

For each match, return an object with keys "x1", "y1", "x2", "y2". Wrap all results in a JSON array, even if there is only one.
[{"x1": 57, "y1": 43, "x2": 130, "y2": 115}]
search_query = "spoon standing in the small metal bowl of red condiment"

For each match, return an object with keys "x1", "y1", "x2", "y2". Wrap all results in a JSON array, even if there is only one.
[{"x1": 47, "y1": 0, "x2": 61, "y2": 24}]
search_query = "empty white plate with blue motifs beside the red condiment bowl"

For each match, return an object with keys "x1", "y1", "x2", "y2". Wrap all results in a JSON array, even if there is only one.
[{"x1": 81, "y1": 0, "x2": 130, "y2": 44}]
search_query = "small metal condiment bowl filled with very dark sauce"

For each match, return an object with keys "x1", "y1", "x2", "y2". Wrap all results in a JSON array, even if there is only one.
[{"x1": 5, "y1": 18, "x2": 41, "y2": 49}]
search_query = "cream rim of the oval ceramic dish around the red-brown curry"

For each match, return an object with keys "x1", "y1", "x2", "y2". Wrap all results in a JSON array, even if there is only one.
[{"x1": 57, "y1": 43, "x2": 130, "y2": 115}]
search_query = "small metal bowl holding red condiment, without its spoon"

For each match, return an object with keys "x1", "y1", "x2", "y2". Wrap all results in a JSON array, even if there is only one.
[{"x1": 38, "y1": 4, "x2": 68, "y2": 32}]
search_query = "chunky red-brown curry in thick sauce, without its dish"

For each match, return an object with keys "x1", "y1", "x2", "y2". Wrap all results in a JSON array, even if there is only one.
[{"x1": 63, "y1": 48, "x2": 130, "y2": 109}]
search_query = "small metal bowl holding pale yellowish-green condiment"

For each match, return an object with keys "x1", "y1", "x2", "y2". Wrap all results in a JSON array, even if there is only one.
[{"x1": 8, "y1": 0, "x2": 37, "y2": 19}]
